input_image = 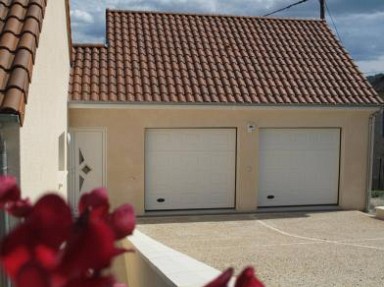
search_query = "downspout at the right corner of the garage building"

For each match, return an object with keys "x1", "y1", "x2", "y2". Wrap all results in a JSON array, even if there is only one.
[{"x1": 365, "y1": 108, "x2": 383, "y2": 212}]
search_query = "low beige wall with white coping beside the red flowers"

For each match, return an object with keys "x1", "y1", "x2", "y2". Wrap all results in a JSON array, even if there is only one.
[{"x1": 116, "y1": 230, "x2": 233, "y2": 287}]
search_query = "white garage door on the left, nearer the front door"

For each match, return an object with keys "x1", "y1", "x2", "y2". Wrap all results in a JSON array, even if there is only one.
[{"x1": 145, "y1": 129, "x2": 236, "y2": 210}]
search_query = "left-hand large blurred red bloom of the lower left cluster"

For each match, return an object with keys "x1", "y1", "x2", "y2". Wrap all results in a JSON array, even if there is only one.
[{"x1": 0, "y1": 194, "x2": 72, "y2": 278}]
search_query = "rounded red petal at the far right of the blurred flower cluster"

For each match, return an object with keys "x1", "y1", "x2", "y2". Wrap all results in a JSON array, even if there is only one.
[{"x1": 109, "y1": 204, "x2": 135, "y2": 239}]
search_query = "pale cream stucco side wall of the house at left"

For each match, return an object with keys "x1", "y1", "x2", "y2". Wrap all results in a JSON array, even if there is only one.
[{"x1": 20, "y1": 0, "x2": 69, "y2": 202}]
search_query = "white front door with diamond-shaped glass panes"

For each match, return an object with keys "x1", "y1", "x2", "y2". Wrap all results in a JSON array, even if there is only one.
[{"x1": 69, "y1": 129, "x2": 106, "y2": 213}]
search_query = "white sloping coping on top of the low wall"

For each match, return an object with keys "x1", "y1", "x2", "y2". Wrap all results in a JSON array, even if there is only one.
[{"x1": 127, "y1": 230, "x2": 234, "y2": 287}]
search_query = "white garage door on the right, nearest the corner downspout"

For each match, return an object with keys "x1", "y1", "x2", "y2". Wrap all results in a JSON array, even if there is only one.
[{"x1": 258, "y1": 129, "x2": 340, "y2": 207}]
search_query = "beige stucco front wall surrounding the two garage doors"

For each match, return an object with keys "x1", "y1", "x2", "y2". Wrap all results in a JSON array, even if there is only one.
[{"x1": 69, "y1": 105, "x2": 374, "y2": 214}]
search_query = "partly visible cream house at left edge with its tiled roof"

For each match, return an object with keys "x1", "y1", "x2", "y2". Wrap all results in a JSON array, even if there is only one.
[{"x1": 0, "y1": 0, "x2": 71, "y2": 200}]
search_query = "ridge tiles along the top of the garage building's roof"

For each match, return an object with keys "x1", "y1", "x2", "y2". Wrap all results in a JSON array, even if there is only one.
[{"x1": 106, "y1": 8, "x2": 326, "y2": 22}]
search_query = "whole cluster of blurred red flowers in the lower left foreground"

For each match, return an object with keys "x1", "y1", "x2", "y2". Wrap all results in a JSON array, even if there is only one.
[{"x1": 0, "y1": 177, "x2": 135, "y2": 287}]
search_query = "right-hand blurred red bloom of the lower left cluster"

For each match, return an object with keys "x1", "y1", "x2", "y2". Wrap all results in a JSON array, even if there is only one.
[{"x1": 56, "y1": 188, "x2": 135, "y2": 286}]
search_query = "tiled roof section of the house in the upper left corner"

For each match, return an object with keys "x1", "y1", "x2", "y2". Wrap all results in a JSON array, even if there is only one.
[{"x1": 0, "y1": 0, "x2": 47, "y2": 119}]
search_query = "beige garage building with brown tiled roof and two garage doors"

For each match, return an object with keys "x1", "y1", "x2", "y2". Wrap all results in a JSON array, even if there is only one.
[{"x1": 69, "y1": 10, "x2": 383, "y2": 215}]
